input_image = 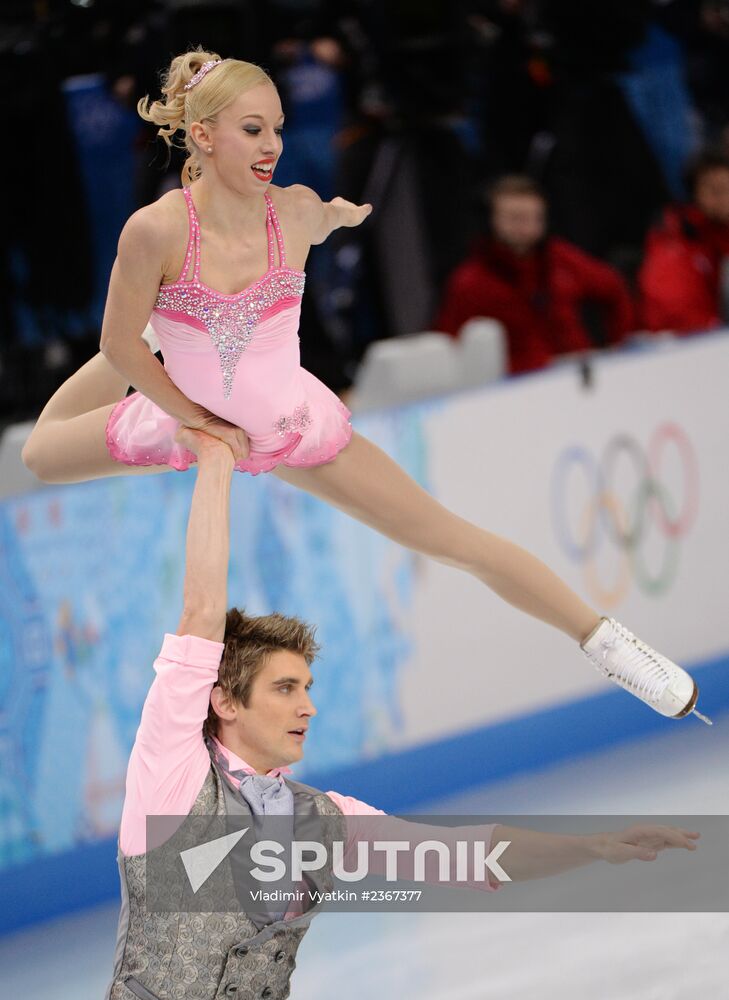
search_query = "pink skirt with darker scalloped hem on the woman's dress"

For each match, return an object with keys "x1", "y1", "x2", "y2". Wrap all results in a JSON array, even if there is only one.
[{"x1": 106, "y1": 369, "x2": 352, "y2": 476}]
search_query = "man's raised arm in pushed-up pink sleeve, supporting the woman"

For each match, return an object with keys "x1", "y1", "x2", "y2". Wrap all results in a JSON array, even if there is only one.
[{"x1": 119, "y1": 429, "x2": 234, "y2": 855}]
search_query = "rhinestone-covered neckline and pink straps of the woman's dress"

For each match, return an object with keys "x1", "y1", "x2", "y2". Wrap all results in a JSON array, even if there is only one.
[{"x1": 155, "y1": 187, "x2": 306, "y2": 400}]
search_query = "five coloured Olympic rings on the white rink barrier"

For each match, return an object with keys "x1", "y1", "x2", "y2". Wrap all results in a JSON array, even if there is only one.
[{"x1": 552, "y1": 423, "x2": 699, "y2": 607}]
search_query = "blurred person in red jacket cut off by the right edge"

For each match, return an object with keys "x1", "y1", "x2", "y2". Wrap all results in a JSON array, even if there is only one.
[{"x1": 638, "y1": 153, "x2": 729, "y2": 333}]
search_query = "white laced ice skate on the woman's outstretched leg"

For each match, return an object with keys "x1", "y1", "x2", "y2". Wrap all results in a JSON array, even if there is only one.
[{"x1": 580, "y1": 618, "x2": 712, "y2": 726}]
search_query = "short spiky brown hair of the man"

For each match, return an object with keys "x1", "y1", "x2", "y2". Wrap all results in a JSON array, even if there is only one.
[{"x1": 204, "y1": 608, "x2": 319, "y2": 736}]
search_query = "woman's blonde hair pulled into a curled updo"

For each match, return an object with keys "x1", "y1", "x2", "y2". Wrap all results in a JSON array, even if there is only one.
[{"x1": 137, "y1": 46, "x2": 274, "y2": 185}]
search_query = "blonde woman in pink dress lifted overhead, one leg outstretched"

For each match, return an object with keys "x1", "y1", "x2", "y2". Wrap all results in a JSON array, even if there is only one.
[{"x1": 23, "y1": 50, "x2": 698, "y2": 718}]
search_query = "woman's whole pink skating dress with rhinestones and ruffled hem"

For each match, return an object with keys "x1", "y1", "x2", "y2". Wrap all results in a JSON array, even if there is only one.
[{"x1": 106, "y1": 187, "x2": 352, "y2": 475}]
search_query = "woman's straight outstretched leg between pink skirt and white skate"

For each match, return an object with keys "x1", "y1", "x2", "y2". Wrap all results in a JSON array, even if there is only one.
[{"x1": 274, "y1": 432, "x2": 600, "y2": 641}]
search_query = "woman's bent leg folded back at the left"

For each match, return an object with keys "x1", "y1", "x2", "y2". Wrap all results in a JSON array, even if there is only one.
[{"x1": 23, "y1": 354, "x2": 169, "y2": 483}]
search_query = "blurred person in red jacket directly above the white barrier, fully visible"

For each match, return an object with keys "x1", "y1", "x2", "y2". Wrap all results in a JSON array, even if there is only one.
[{"x1": 436, "y1": 175, "x2": 633, "y2": 372}]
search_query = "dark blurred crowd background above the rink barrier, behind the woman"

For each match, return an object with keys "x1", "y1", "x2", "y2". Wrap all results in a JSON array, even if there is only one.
[{"x1": 0, "y1": 0, "x2": 729, "y2": 422}]
